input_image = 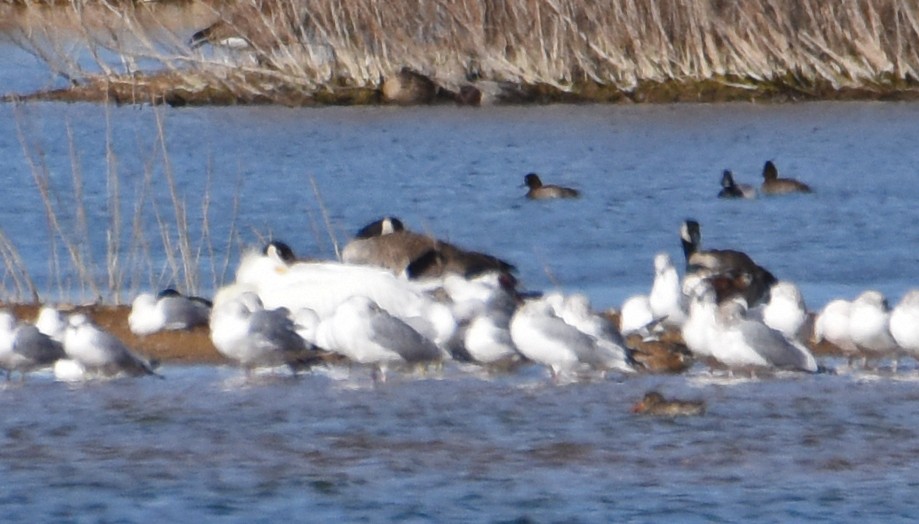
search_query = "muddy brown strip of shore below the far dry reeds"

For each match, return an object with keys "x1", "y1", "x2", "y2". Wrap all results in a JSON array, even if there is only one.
[{"x1": 6, "y1": 70, "x2": 919, "y2": 107}]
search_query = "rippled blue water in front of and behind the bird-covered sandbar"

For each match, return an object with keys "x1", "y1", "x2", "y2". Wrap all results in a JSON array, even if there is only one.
[{"x1": 0, "y1": 39, "x2": 919, "y2": 522}]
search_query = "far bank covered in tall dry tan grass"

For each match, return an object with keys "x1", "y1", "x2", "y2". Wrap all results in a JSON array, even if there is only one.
[{"x1": 7, "y1": 0, "x2": 919, "y2": 105}]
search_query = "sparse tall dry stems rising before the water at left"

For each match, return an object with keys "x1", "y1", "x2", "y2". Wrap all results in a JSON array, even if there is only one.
[{"x1": 6, "y1": 106, "x2": 240, "y2": 304}]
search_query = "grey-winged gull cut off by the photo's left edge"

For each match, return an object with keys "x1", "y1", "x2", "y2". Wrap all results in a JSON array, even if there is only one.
[{"x1": 0, "y1": 311, "x2": 64, "y2": 379}]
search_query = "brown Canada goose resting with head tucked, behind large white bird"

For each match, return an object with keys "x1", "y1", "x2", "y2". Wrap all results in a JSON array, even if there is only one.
[{"x1": 342, "y1": 217, "x2": 516, "y2": 278}]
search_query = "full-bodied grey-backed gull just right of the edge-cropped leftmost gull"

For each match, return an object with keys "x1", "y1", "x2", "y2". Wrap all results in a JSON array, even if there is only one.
[{"x1": 64, "y1": 313, "x2": 159, "y2": 376}]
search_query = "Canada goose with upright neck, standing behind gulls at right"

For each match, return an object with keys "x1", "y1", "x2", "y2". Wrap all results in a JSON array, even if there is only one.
[{"x1": 680, "y1": 220, "x2": 778, "y2": 307}]
